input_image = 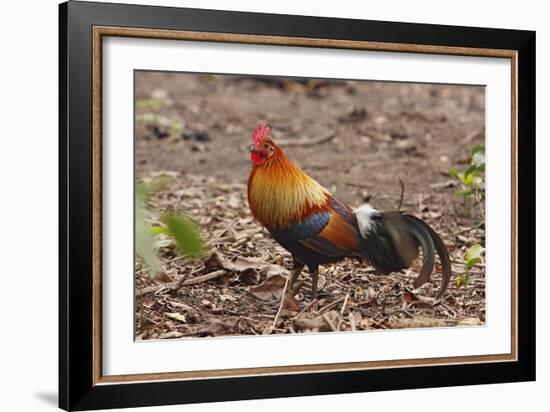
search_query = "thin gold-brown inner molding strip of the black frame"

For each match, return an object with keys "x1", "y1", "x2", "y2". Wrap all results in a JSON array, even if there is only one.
[{"x1": 92, "y1": 26, "x2": 518, "y2": 385}]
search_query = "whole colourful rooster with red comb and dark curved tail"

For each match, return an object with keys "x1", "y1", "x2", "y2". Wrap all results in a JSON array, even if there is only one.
[{"x1": 248, "y1": 123, "x2": 451, "y2": 299}]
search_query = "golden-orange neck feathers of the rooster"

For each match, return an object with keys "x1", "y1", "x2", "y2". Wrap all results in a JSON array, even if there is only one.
[{"x1": 248, "y1": 145, "x2": 330, "y2": 229}]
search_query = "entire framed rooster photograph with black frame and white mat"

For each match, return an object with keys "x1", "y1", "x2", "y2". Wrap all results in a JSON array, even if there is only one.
[{"x1": 59, "y1": 1, "x2": 535, "y2": 410}]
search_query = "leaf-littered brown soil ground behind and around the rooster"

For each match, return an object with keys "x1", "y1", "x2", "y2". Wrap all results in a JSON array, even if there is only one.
[{"x1": 135, "y1": 72, "x2": 485, "y2": 339}]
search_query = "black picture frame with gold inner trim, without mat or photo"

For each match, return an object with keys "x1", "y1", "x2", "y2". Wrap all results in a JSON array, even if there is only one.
[{"x1": 59, "y1": 1, "x2": 535, "y2": 410}]
